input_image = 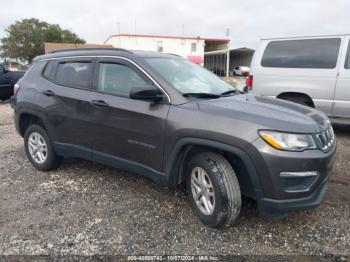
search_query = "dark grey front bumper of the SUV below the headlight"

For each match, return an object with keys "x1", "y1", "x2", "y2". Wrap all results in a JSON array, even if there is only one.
[{"x1": 250, "y1": 136, "x2": 336, "y2": 216}]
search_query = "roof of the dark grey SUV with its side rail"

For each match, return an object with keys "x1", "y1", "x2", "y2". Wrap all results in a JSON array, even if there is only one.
[{"x1": 33, "y1": 48, "x2": 176, "y2": 62}]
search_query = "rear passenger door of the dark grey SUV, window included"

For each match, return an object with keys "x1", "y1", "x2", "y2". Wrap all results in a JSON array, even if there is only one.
[{"x1": 36, "y1": 58, "x2": 94, "y2": 157}]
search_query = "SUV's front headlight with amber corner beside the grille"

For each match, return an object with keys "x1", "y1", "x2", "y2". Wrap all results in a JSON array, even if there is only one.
[{"x1": 259, "y1": 130, "x2": 316, "y2": 151}]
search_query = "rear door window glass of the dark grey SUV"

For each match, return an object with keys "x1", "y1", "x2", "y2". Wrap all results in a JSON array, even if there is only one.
[{"x1": 55, "y1": 61, "x2": 92, "y2": 88}]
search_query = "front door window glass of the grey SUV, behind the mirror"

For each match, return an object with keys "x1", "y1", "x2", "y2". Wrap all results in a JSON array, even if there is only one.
[{"x1": 98, "y1": 63, "x2": 149, "y2": 97}]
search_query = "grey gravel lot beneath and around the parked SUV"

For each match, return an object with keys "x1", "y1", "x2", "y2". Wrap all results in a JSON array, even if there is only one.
[{"x1": 0, "y1": 104, "x2": 350, "y2": 260}]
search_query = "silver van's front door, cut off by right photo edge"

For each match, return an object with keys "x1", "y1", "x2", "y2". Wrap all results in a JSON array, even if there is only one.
[{"x1": 333, "y1": 36, "x2": 350, "y2": 117}]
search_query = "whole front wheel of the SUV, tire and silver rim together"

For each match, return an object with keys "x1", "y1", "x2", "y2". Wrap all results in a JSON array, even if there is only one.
[{"x1": 186, "y1": 152, "x2": 242, "y2": 228}]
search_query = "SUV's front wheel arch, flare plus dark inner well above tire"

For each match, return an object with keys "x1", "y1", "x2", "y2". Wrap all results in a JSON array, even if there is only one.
[{"x1": 165, "y1": 138, "x2": 262, "y2": 199}]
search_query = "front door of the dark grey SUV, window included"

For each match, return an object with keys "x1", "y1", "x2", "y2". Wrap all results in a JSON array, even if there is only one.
[{"x1": 90, "y1": 58, "x2": 170, "y2": 171}]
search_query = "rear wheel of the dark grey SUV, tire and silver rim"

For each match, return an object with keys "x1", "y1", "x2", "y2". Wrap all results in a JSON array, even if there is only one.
[{"x1": 24, "y1": 125, "x2": 62, "y2": 171}]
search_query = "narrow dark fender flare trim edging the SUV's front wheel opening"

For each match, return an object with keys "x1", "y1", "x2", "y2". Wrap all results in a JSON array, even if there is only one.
[{"x1": 164, "y1": 137, "x2": 263, "y2": 200}]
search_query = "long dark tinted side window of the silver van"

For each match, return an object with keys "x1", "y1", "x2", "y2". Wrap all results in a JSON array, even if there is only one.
[{"x1": 261, "y1": 38, "x2": 340, "y2": 68}]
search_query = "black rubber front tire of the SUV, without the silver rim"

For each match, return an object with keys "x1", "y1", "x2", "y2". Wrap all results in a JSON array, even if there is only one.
[{"x1": 186, "y1": 152, "x2": 242, "y2": 228}]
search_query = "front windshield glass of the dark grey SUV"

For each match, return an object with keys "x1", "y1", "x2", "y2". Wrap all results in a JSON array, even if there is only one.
[{"x1": 146, "y1": 57, "x2": 234, "y2": 95}]
